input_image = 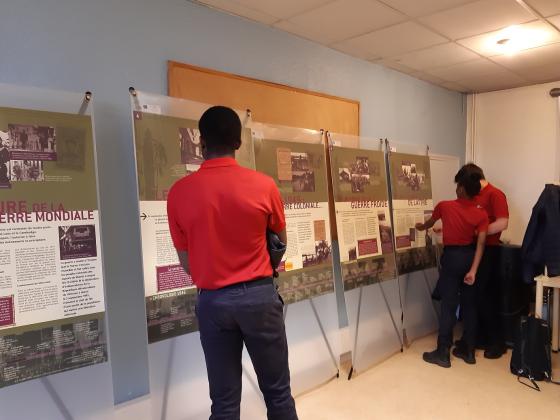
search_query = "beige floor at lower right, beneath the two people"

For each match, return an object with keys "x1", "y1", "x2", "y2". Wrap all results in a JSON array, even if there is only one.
[{"x1": 297, "y1": 337, "x2": 560, "y2": 420}]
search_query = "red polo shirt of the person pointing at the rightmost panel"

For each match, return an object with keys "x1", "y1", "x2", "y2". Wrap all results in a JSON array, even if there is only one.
[{"x1": 432, "y1": 198, "x2": 488, "y2": 245}]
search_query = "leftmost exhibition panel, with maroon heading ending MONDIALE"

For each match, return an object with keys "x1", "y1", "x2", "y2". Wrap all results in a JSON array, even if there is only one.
[{"x1": 0, "y1": 84, "x2": 107, "y2": 388}]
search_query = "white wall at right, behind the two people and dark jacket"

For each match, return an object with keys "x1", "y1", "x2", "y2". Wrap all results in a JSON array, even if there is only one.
[{"x1": 467, "y1": 82, "x2": 560, "y2": 244}]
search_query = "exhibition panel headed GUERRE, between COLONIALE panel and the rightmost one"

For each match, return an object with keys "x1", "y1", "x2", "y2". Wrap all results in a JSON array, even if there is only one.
[{"x1": 328, "y1": 132, "x2": 402, "y2": 373}]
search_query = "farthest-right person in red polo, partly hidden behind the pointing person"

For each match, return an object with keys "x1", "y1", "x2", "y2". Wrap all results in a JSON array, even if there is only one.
[{"x1": 458, "y1": 163, "x2": 509, "y2": 359}]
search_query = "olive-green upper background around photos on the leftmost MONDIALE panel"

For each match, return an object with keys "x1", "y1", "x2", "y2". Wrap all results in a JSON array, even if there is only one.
[{"x1": 0, "y1": 107, "x2": 97, "y2": 210}]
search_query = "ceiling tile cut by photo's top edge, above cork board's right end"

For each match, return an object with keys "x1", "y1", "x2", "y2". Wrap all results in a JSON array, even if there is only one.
[{"x1": 277, "y1": 0, "x2": 407, "y2": 44}]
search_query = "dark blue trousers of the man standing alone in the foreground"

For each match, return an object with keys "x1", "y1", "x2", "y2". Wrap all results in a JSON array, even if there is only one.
[{"x1": 196, "y1": 281, "x2": 297, "y2": 420}]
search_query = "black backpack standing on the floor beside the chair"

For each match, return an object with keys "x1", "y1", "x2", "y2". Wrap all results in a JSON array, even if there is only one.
[{"x1": 510, "y1": 316, "x2": 557, "y2": 391}]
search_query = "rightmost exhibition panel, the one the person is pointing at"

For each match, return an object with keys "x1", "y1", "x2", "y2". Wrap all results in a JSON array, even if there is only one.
[{"x1": 386, "y1": 142, "x2": 439, "y2": 345}]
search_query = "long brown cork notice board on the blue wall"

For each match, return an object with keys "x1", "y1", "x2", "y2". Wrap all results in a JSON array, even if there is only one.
[{"x1": 168, "y1": 61, "x2": 360, "y2": 135}]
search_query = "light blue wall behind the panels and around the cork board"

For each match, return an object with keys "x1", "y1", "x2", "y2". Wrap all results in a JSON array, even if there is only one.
[{"x1": 0, "y1": 0, "x2": 466, "y2": 400}]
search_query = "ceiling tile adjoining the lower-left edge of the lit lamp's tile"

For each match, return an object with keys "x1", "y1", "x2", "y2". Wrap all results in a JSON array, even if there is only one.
[{"x1": 394, "y1": 43, "x2": 478, "y2": 70}]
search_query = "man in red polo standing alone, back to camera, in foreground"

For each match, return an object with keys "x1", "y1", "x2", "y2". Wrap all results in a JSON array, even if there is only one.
[{"x1": 167, "y1": 106, "x2": 297, "y2": 420}]
